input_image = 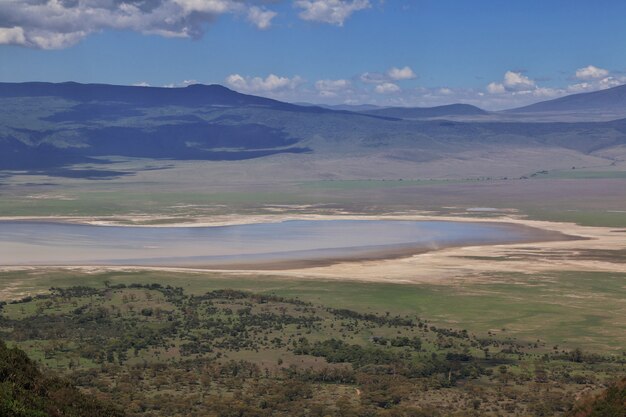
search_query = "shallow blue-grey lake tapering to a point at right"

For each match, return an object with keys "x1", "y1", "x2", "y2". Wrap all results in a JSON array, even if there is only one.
[{"x1": 0, "y1": 220, "x2": 555, "y2": 269}]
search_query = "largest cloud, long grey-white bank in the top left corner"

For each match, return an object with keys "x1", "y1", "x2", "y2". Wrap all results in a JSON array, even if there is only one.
[{"x1": 0, "y1": 0, "x2": 276, "y2": 49}]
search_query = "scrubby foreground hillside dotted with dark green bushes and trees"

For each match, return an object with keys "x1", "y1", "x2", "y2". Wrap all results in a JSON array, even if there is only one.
[{"x1": 0, "y1": 280, "x2": 626, "y2": 417}]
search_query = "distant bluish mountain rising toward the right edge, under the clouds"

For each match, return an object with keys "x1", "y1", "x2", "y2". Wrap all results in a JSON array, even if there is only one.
[{"x1": 506, "y1": 84, "x2": 626, "y2": 113}]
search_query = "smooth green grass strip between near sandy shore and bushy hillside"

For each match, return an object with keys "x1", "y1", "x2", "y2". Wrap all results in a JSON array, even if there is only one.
[{"x1": 0, "y1": 271, "x2": 626, "y2": 352}]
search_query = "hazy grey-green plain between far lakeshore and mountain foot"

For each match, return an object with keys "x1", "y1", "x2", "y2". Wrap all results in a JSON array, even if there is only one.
[{"x1": 0, "y1": 162, "x2": 626, "y2": 227}]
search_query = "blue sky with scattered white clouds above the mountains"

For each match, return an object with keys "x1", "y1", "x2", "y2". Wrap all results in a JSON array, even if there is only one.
[{"x1": 0, "y1": 0, "x2": 626, "y2": 110}]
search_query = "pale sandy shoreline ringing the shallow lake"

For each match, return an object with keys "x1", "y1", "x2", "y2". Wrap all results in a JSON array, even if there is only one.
[{"x1": 0, "y1": 214, "x2": 626, "y2": 283}]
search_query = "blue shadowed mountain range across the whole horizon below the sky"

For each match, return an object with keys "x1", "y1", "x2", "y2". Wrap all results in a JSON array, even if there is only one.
[{"x1": 0, "y1": 82, "x2": 626, "y2": 178}]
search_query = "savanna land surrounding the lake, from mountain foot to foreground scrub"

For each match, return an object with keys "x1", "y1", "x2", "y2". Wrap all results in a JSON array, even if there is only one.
[{"x1": 0, "y1": 162, "x2": 626, "y2": 416}]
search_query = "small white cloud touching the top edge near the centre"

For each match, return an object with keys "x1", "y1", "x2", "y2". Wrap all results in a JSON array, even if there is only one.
[{"x1": 294, "y1": 0, "x2": 372, "y2": 26}]
